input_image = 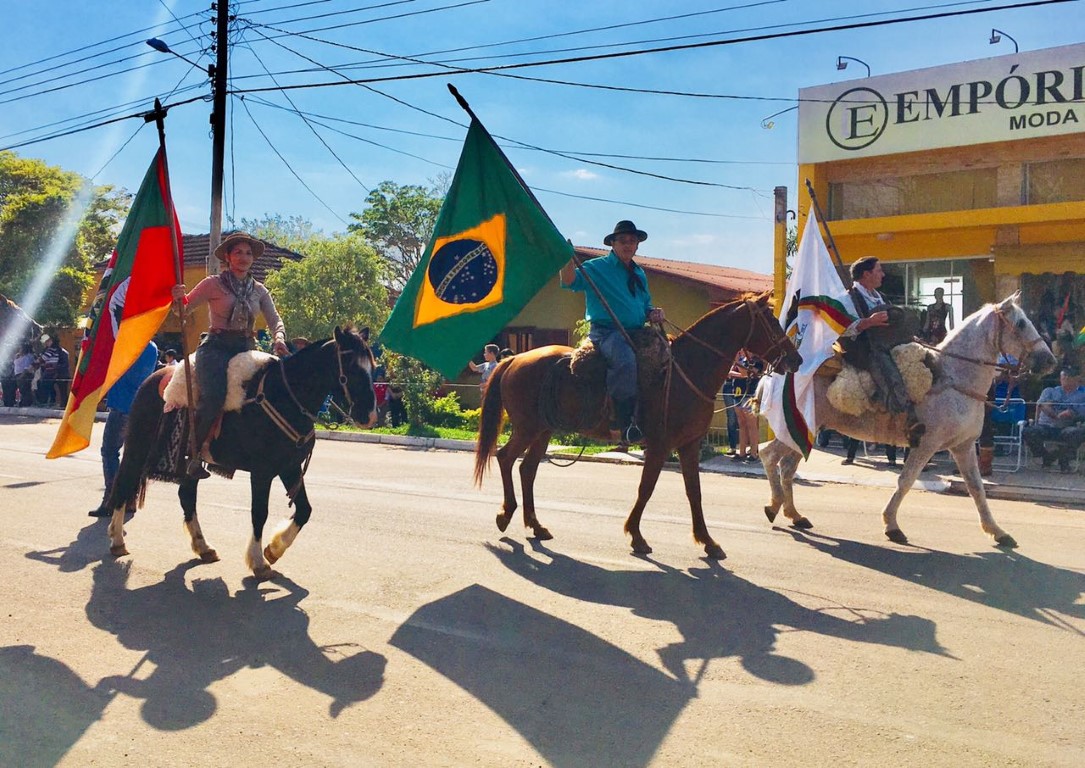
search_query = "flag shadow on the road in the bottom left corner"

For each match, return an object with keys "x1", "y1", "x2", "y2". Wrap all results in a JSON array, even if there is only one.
[{"x1": 0, "y1": 645, "x2": 113, "y2": 768}]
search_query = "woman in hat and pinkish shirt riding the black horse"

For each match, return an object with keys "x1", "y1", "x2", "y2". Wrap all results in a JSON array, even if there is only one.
[{"x1": 173, "y1": 232, "x2": 288, "y2": 478}]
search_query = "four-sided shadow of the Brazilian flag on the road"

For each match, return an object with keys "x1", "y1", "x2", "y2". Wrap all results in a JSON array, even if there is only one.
[{"x1": 390, "y1": 585, "x2": 693, "y2": 768}]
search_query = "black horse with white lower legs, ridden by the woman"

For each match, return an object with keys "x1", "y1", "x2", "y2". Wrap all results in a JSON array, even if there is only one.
[{"x1": 109, "y1": 328, "x2": 376, "y2": 579}]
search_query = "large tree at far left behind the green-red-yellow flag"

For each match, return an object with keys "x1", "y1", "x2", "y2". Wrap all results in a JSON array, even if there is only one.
[{"x1": 0, "y1": 152, "x2": 130, "y2": 327}]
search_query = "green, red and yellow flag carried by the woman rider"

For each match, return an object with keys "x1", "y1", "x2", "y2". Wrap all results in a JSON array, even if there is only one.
[{"x1": 46, "y1": 149, "x2": 183, "y2": 459}]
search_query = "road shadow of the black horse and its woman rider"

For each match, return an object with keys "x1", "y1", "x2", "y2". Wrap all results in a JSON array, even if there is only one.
[{"x1": 86, "y1": 559, "x2": 386, "y2": 731}]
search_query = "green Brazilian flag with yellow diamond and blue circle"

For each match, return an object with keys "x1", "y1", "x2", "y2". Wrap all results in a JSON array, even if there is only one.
[{"x1": 381, "y1": 119, "x2": 573, "y2": 379}]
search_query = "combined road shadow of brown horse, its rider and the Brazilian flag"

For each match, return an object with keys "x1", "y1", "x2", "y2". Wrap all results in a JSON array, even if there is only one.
[{"x1": 391, "y1": 538, "x2": 944, "y2": 766}]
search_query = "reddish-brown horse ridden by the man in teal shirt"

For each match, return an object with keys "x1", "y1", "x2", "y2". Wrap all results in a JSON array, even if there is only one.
[{"x1": 475, "y1": 293, "x2": 802, "y2": 560}]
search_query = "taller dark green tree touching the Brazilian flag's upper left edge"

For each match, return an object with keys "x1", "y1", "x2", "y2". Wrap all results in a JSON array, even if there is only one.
[{"x1": 349, "y1": 181, "x2": 443, "y2": 287}]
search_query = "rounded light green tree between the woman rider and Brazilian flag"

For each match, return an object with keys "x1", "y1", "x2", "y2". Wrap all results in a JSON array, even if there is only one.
[{"x1": 267, "y1": 233, "x2": 388, "y2": 340}]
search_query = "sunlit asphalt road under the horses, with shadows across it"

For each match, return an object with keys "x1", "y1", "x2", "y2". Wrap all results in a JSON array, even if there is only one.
[{"x1": 0, "y1": 418, "x2": 1085, "y2": 768}]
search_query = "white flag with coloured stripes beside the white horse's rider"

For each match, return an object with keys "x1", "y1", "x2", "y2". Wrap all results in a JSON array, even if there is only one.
[{"x1": 761, "y1": 213, "x2": 858, "y2": 458}]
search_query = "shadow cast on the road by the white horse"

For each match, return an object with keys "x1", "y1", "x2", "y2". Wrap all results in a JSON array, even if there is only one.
[{"x1": 777, "y1": 526, "x2": 1085, "y2": 635}]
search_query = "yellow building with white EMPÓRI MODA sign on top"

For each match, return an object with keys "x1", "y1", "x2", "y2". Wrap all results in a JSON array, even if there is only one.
[{"x1": 789, "y1": 44, "x2": 1085, "y2": 351}]
